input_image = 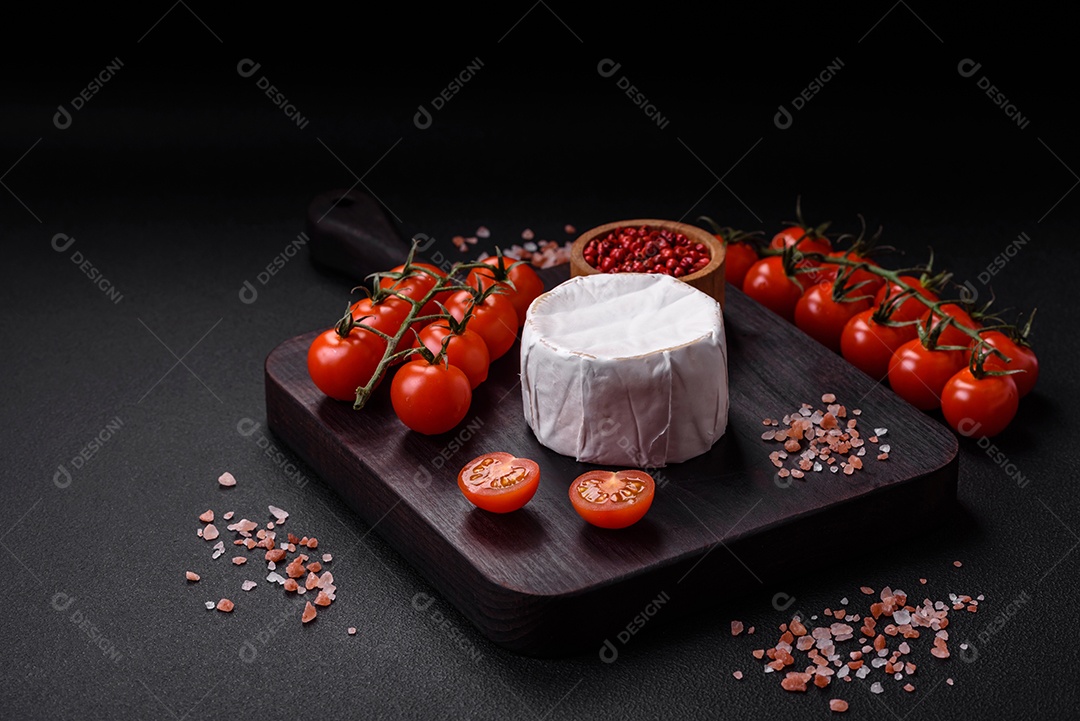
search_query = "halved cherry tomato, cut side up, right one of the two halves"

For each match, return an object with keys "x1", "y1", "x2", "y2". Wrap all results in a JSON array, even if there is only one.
[{"x1": 570, "y1": 471, "x2": 657, "y2": 528}]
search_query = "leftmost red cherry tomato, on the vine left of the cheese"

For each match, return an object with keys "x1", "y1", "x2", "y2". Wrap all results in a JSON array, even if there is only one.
[{"x1": 308, "y1": 328, "x2": 387, "y2": 400}]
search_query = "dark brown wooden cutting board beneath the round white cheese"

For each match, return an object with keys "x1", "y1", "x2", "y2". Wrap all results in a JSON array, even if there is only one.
[{"x1": 266, "y1": 189, "x2": 958, "y2": 655}]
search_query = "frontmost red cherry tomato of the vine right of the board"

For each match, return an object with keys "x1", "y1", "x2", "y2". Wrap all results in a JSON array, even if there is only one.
[{"x1": 942, "y1": 368, "x2": 1020, "y2": 437}]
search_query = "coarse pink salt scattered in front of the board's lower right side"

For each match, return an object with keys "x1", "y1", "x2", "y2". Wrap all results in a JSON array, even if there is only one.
[{"x1": 731, "y1": 565, "x2": 984, "y2": 712}]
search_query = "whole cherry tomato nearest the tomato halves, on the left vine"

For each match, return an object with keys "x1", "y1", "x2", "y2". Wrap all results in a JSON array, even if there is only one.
[{"x1": 390, "y1": 358, "x2": 472, "y2": 435}]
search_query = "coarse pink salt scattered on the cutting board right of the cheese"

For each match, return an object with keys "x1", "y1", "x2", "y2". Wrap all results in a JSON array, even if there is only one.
[{"x1": 761, "y1": 393, "x2": 892, "y2": 480}]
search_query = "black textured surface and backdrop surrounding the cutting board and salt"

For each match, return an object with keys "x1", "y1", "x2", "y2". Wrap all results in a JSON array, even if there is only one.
[{"x1": 0, "y1": 3, "x2": 1080, "y2": 720}]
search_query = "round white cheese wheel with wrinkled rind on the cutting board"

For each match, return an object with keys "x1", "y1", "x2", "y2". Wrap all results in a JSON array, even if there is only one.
[{"x1": 521, "y1": 273, "x2": 729, "y2": 468}]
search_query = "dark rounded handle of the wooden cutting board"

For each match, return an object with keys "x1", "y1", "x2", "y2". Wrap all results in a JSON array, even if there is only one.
[{"x1": 307, "y1": 188, "x2": 409, "y2": 283}]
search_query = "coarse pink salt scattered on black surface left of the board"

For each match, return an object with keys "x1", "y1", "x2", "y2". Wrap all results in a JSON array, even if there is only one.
[{"x1": 185, "y1": 473, "x2": 356, "y2": 635}]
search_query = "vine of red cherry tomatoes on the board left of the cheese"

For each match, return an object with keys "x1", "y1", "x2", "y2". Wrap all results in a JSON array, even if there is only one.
[{"x1": 308, "y1": 254, "x2": 543, "y2": 435}]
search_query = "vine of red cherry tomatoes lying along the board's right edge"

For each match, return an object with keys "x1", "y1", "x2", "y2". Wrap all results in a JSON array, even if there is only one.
[{"x1": 703, "y1": 205, "x2": 1039, "y2": 436}]
